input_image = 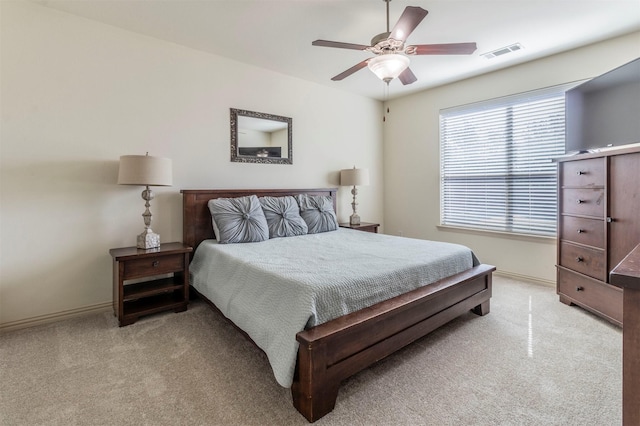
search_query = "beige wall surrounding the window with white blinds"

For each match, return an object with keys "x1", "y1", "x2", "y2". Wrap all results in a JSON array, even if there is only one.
[{"x1": 384, "y1": 33, "x2": 640, "y2": 282}]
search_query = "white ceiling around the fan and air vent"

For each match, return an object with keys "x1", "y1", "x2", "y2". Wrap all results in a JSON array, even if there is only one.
[{"x1": 34, "y1": 0, "x2": 640, "y2": 99}]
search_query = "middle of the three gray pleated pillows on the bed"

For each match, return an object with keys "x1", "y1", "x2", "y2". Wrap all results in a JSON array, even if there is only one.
[{"x1": 258, "y1": 196, "x2": 307, "y2": 238}]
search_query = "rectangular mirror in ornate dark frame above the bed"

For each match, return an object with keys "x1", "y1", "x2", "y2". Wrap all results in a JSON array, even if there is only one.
[{"x1": 230, "y1": 108, "x2": 293, "y2": 164}]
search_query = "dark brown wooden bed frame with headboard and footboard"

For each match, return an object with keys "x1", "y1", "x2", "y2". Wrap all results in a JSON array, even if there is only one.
[{"x1": 181, "y1": 188, "x2": 495, "y2": 422}]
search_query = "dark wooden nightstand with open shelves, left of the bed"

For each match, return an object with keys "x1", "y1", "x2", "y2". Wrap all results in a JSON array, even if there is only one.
[{"x1": 109, "y1": 243, "x2": 193, "y2": 327}]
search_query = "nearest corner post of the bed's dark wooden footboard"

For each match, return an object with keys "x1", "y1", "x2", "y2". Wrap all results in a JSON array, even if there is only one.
[{"x1": 291, "y1": 334, "x2": 340, "y2": 422}]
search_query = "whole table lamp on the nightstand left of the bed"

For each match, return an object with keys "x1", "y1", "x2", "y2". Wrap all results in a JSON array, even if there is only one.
[{"x1": 118, "y1": 152, "x2": 172, "y2": 250}]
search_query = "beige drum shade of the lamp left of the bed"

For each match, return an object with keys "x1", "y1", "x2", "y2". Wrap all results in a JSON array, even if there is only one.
[{"x1": 118, "y1": 155, "x2": 173, "y2": 186}]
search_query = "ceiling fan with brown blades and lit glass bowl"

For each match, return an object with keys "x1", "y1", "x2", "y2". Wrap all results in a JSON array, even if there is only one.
[{"x1": 311, "y1": 0, "x2": 476, "y2": 85}]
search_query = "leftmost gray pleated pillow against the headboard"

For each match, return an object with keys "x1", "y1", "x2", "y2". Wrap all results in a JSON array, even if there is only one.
[{"x1": 207, "y1": 195, "x2": 269, "y2": 244}]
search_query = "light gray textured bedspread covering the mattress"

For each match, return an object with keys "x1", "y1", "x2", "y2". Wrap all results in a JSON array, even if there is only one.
[{"x1": 190, "y1": 228, "x2": 478, "y2": 387}]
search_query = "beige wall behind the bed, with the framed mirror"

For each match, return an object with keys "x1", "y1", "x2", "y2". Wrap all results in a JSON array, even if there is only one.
[{"x1": 0, "y1": 1, "x2": 383, "y2": 326}]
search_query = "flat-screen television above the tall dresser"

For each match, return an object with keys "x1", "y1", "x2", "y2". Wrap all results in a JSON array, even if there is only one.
[{"x1": 565, "y1": 58, "x2": 640, "y2": 154}]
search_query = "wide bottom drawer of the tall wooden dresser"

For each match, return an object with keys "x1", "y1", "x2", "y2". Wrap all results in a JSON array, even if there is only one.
[{"x1": 558, "y1": 268, "x2": 622, "y2": 325}]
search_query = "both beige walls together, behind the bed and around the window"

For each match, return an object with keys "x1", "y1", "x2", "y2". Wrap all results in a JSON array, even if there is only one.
[{"x1": 0, "y1": 1, "x2": 640, "y2": 327}]
